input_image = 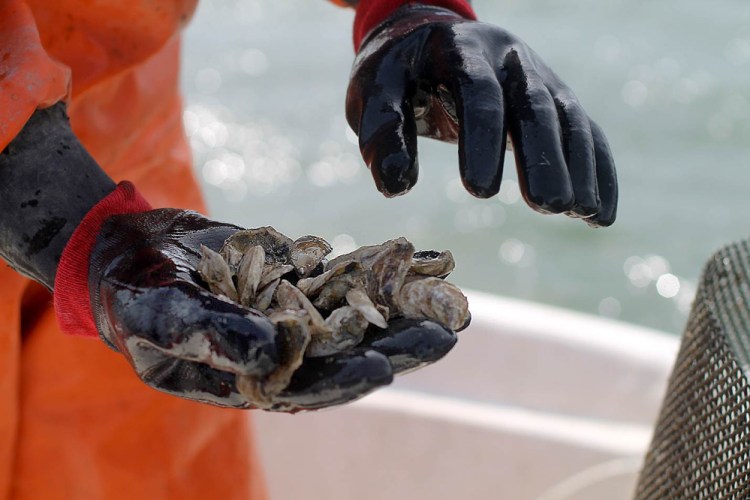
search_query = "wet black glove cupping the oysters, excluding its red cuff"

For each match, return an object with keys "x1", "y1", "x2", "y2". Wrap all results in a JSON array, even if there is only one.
[{"x1": 89, "y1": 209, "x2": 456, "y2": 412}]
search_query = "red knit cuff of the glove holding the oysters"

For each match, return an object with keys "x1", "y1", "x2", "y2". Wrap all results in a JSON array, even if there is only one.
[{"x1": 54, "y1": 181, "x2": 151, "y2": 338}]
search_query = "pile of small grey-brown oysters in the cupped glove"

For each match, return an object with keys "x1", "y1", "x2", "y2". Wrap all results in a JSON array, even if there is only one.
[{"x1": 198, "y1": 227, "x2": 469, "y2": 407}]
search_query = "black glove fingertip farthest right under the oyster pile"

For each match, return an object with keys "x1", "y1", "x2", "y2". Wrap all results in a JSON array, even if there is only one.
[{"x1": 357, "y1": 318, "x2": 458, "y2": 375}]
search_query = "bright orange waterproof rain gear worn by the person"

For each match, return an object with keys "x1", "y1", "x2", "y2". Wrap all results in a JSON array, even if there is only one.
[{"x1": 0, "y1": 0, "x2": 347, "y2": 500}]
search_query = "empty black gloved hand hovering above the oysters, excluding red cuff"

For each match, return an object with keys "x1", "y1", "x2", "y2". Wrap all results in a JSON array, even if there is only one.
[{"x1": 346, "y1": 3, "x2": 617, "y2": 226}]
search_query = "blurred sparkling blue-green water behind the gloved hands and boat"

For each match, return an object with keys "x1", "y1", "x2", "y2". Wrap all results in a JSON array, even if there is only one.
[{"x1": 183, "y1": 0, "x2": 750, "y2": 332}]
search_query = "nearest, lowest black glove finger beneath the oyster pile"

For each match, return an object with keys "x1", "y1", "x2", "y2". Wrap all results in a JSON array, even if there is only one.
[{"x1": 273, "y1": 350, "x2": 393, "y2": 412}]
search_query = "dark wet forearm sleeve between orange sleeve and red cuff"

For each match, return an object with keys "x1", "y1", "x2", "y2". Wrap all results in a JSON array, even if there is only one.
[{"x1": 0, "y1": 103, "x2": 115, "y2": 290}]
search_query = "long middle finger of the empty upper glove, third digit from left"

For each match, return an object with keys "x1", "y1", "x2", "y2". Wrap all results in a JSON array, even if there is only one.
[{"x1": 503, "y1": 51, "x2": 575, "y2": 213}]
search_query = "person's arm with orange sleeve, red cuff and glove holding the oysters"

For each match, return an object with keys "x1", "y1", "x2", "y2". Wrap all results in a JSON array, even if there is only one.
[{"x1": 0, "y1": 0, "x2": 456, "y2": 411}]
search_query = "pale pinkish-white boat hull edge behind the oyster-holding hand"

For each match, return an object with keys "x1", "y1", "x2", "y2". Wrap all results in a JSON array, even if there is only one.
[{"x1": 255, "y1": 292, "x2": 678, "y2": 500}]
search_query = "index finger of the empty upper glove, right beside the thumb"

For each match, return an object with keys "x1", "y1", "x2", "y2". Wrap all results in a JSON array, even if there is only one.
[{"x1": 451, "y1": 60, "x2": 507, "y2": 198}]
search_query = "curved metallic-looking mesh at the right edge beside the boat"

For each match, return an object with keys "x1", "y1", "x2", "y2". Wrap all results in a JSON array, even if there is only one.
[{"x1": 636, "y1": 241, "x2": 750, "y2": 500}]
